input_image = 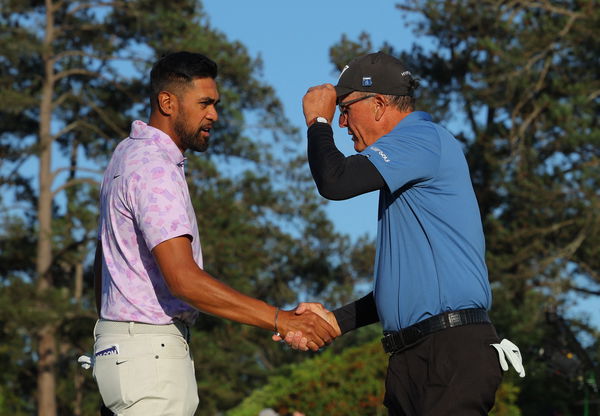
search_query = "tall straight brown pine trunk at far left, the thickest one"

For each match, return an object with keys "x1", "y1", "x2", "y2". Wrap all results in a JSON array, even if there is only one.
[{"x1": 36, "y1": 0, "x2": 56, "y2": 416}]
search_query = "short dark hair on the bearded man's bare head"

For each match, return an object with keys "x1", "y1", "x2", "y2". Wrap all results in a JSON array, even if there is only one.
[{"x1": 150, "y1": 51, "x2": 217, "y2": 102}]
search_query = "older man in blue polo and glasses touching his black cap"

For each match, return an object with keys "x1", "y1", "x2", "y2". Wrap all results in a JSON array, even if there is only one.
[{"x1": 286, "y1": 52, "x2": 516, "y2": 416}]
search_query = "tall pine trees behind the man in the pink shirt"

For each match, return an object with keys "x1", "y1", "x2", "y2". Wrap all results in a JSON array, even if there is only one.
[{"x1": 0, "y1": 0, "x2": 370, "y2": 416}]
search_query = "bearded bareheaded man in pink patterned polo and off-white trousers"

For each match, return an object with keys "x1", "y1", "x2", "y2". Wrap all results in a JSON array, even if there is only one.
[{"x1": 94, "y1": 52, "x2": 335, "y2": 415}]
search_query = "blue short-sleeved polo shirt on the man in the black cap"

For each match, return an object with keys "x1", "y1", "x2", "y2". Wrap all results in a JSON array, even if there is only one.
[{"x1": 361, "y1": 111, "x2": 492, "y2": 331}]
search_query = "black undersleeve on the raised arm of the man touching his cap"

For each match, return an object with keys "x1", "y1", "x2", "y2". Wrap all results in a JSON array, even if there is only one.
[{"x1": 308, "y1": 123, "x2": 385, "y2": 200}]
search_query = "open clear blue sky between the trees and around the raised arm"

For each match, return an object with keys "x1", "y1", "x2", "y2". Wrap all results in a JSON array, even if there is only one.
[{"x1": 204, "y1": 0, "x2": 415, "y2": 237}]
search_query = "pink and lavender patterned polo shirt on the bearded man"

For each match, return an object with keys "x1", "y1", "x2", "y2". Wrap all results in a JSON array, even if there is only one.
[{"x1": 98, "y1": 120, "x2": 202, "y2": 324}]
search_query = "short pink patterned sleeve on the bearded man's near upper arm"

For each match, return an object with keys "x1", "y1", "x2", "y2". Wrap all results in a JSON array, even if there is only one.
[{"x1": 128, "y1": 165, "x2": 193, "y2": 250}]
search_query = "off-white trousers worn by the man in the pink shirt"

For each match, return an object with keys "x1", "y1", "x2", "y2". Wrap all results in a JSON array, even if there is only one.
[{"x1": 93, "y1": 320, "x2": 199, "y2": 416}]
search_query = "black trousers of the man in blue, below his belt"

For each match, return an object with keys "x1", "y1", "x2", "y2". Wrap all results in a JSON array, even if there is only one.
[{"x1": 384, "y1": 324, "x2": 502, "y2": 416}]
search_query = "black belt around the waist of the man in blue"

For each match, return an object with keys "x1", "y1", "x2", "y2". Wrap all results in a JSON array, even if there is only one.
[{"x1": 381, "y1": 309, "x2": 492, "y2": 354}]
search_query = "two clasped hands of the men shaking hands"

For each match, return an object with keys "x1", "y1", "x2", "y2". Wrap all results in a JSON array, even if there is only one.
[{"x1": 272, "y1": 302, "x2": 342, "y2": 351}]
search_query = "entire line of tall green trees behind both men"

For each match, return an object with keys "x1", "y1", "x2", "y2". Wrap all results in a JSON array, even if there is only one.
[{"x1": 0, "y1": 0, "x2": 600, "y2": 416}]
